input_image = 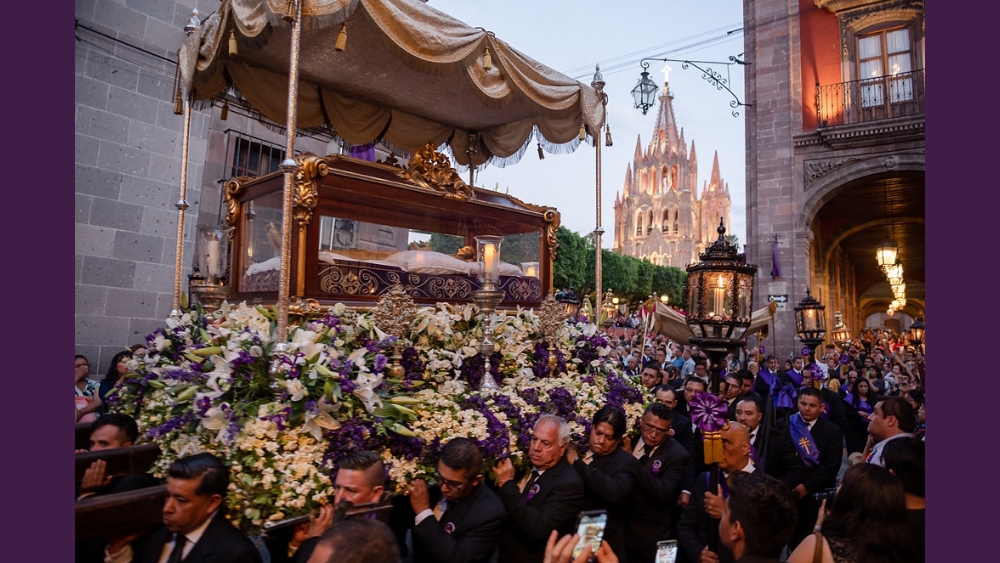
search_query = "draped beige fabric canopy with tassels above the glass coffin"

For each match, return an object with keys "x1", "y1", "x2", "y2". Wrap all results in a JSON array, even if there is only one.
[{"x1": 179, "y1": 0, "x2": 605, "y2": 166}]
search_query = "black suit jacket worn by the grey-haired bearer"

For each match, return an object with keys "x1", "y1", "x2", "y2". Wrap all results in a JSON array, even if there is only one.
[{"x1": 497, "y1": 457, "x2": 583, "y2": 563}]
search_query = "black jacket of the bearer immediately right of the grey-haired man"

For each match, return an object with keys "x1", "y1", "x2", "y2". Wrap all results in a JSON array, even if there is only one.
[{"x1": 573, "y1": 448, "x2": 639, "y2": 554}]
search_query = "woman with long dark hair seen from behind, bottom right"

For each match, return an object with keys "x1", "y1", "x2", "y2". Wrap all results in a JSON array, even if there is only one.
[{"x1": 788, "y1": 463, "x2": 915, "y2": 563}]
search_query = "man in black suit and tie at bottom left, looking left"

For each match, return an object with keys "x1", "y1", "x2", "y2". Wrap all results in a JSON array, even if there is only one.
[{"x1": 108, "y1": 453, "x2": 261, "y2": 563}]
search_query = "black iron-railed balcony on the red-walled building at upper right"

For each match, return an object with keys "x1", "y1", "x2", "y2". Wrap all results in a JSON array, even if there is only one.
[{"x1": 816, "y1": 69, "x2": 926, "y2": 128}]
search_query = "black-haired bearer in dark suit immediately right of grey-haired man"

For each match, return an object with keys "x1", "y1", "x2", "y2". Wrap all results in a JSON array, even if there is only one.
[{"x1": 566, "y1": 405, "x2": 639, "y2": 554}]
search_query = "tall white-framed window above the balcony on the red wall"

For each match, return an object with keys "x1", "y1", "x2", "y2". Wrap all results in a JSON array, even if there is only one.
[{"x1": 858, "y1": 27, "x2": 913, "y2": 108}]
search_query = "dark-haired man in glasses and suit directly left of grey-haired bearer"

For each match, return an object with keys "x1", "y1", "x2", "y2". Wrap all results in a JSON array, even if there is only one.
[{"x1": 409, "y1": 438, "x2": 506, "y2": 563}]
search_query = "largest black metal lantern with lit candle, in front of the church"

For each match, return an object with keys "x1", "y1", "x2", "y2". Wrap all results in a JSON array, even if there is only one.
[{"x1": 685, "y1": 218, "x2": 757, "y2": 393}]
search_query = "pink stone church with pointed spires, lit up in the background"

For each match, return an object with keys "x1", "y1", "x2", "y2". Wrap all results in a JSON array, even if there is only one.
[{"x1": 613, "y1": 84, "x2": 731, "y2": 268}]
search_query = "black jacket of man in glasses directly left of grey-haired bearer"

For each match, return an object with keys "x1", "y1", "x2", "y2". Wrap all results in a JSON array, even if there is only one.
[{"x1": 412, "y1": 483, "x2": 506, "y2": 563}]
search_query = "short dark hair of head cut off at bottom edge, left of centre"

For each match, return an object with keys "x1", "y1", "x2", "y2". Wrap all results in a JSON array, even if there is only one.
[{"x1": 317, "y1": 518, "x2": 401, "y2": 563}]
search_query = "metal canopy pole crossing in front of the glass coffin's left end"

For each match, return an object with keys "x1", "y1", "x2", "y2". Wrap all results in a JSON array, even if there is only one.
[{"x1": 275, "y1": 0, "x2": 302, "y2": 347}]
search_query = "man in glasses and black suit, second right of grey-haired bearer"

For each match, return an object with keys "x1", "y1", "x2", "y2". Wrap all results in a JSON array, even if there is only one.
[{"x1": 625, "y1": 402, "x2": 691, "y2": 561}]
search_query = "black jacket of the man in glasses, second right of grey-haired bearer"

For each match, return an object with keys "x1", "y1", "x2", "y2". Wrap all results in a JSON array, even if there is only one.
[{"x1": 625, "y1": 436, "x2": 691, "y2": 561}]
